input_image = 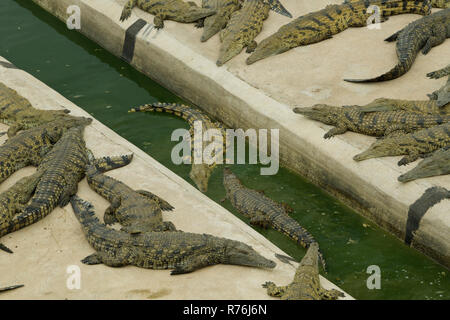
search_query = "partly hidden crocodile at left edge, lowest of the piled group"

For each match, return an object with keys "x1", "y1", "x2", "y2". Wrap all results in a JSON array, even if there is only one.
[{"x1": 0, "y1": 171, "x2": 43, "y2": 253}]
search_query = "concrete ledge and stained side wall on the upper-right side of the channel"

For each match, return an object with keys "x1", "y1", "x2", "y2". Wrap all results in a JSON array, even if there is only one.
[{"x1": 33, "y1": 0, "x2": 450, "y2": 267}]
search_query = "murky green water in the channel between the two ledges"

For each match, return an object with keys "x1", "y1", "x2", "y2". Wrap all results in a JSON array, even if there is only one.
[{"x1": 0, "y1": 0, "x2": 450, "y2": 299}]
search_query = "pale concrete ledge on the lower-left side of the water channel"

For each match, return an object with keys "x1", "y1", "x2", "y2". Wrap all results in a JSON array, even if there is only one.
[{"x1": 0, "y1": 57, "x2": 352, "y2": 299}]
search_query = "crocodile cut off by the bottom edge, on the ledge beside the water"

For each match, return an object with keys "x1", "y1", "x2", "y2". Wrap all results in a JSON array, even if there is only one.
[{"x1": 262, "y1": 243, "x2": 345, "y2": 300}]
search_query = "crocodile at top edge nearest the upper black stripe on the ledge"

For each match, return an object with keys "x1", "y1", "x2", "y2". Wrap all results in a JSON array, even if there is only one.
[{"x1": 120, "y1": 0, "x2": 216, "y2": 29}]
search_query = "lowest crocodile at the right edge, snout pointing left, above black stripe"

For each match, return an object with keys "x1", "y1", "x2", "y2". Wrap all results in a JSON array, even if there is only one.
[{"x1": 398, "y1": 145, "x2": 450, "y2": 182}]
